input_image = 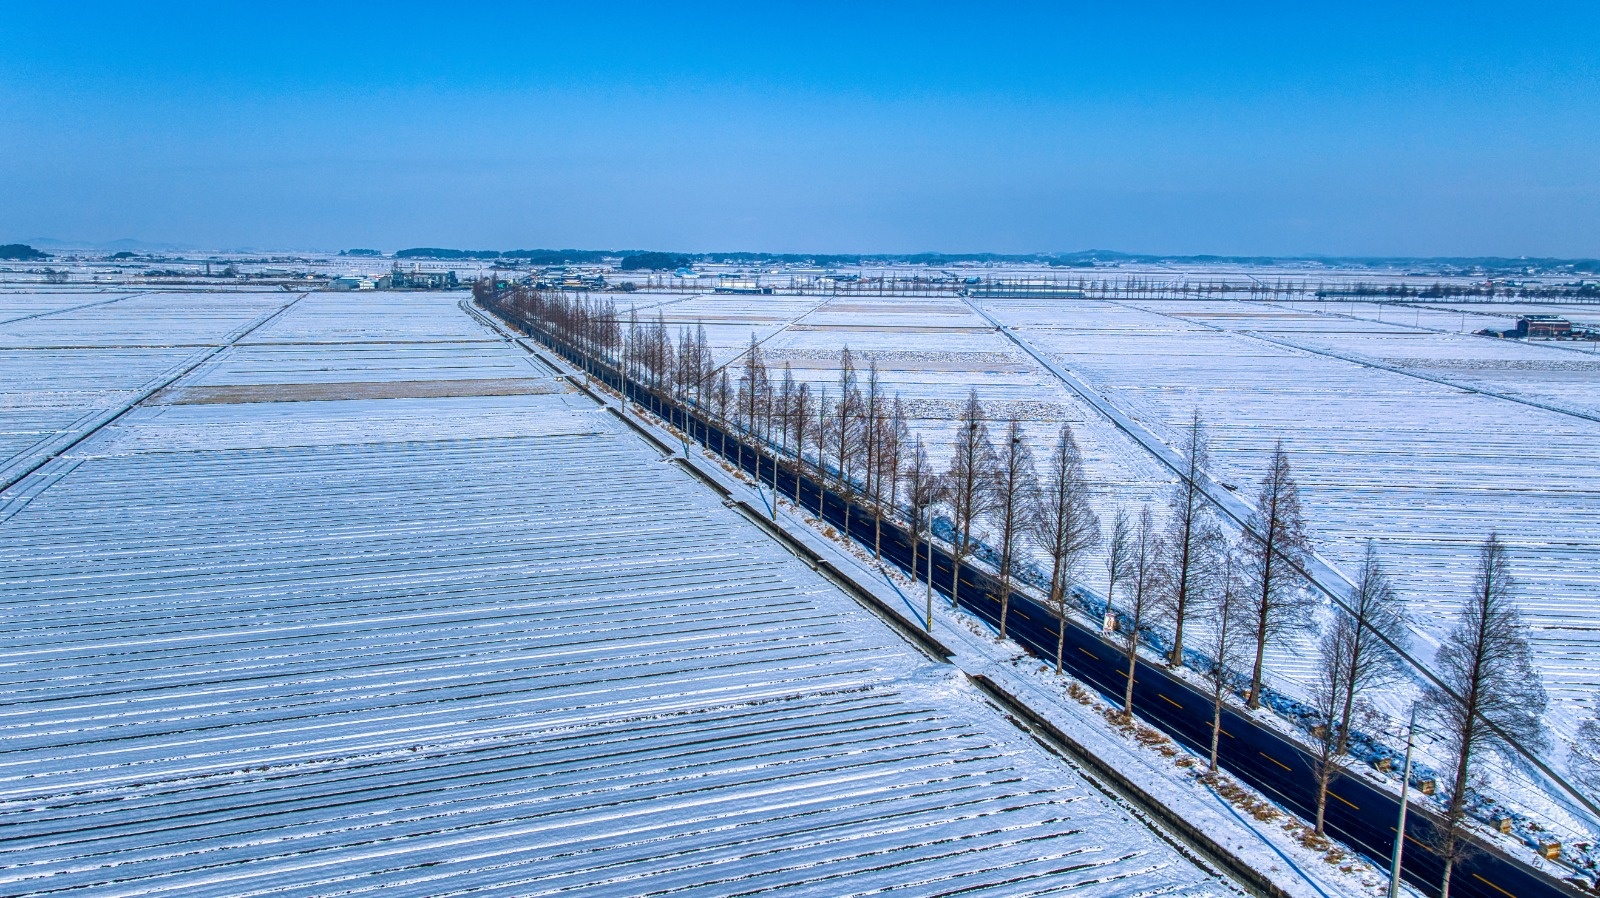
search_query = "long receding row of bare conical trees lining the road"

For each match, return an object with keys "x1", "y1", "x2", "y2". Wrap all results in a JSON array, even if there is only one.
[{"x1": 476, "y1": 290, "x2": 1548, "y2": 895}]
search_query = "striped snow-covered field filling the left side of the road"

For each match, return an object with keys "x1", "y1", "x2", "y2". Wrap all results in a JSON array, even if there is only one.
[{"x1": 0, "y1": 295, "x2": 1229, "y2": 895}]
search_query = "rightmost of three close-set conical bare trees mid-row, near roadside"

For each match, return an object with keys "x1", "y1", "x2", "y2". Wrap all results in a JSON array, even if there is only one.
[{"x1": 1032, "y1": 424, "x2": 1100, "y2": 676}]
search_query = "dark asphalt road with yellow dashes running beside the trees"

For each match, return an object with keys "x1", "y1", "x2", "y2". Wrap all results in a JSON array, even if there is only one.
[{"x1": 518, "y1": 315, "x2": 1582, "y2": 898}]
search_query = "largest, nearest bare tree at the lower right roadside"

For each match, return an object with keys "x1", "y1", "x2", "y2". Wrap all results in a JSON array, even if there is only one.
[{"x1": 1422, "y1": 533, "x2": 1547, "y2": 898}]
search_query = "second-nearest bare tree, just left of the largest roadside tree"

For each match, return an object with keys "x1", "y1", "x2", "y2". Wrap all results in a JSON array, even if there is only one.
[{"x1": 1310, "y1": 543, "x2": 1408, "y2": 836}]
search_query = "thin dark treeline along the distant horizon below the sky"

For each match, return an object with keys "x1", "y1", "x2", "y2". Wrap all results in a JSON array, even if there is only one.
[{"x1": 394, "y1": 247, "x2": 1600, "y2": 274}]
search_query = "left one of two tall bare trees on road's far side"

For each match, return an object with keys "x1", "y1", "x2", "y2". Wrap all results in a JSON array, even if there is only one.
[{"x1": 1162, "y1": 411, "x2": 1222, "y2": 667}]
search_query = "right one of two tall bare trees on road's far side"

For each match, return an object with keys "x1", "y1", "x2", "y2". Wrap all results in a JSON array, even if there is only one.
[{"x1": 1240, "y1": 440, "x2": 1317, "y2": 709}]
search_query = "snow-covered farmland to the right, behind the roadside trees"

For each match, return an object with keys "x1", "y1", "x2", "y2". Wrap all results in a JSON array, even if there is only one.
[{"x1": 633, "y1": 286, "x2": 1600, "y2": 825}]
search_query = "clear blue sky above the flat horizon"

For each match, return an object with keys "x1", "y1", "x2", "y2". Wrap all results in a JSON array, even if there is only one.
[{"x1": 0, "y1": 2, "x2": 1600, "y2": 256}]
